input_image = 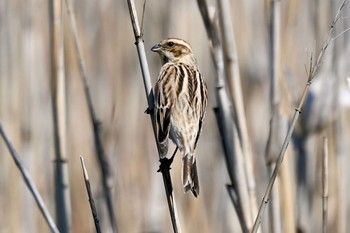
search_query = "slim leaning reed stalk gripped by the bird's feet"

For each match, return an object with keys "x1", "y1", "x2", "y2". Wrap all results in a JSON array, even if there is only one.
[{"x1": 127, "y1": 0, "x2": 181, "y2": 233}]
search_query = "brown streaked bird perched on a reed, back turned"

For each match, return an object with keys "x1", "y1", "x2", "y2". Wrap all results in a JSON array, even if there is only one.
[{"x1": 151, "y1": 38, "x2": 208, "y2": 197}]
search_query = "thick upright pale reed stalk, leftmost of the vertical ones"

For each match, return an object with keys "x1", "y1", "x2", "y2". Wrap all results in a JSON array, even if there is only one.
[{"x1": 49, "y1": 0, "x2": 72, "y2": 233}]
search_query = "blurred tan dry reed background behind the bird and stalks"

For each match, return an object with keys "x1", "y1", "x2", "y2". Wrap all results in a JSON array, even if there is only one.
[{"x1": 0, "y1": 0, "x2": 350, "y2": 233}]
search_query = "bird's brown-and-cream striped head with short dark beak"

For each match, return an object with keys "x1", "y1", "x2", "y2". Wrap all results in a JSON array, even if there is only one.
[{"x1": 151, "y1": 38, "x2": 196, "y2": 66}]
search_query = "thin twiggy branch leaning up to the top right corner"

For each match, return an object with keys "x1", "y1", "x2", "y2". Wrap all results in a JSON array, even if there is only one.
[{"x1": 252, "y1": 0, "x2": 349, "y2": 233}]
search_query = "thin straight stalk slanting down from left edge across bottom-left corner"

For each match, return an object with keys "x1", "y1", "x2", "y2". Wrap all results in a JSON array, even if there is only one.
[{"x1": 0, "y1": 122, "x2": 59, "y2": 233}]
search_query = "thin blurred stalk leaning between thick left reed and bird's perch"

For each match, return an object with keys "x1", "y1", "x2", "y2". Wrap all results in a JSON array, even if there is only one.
[{"x1": 66, "y1": 0, "x2": 118, "y2": 233}]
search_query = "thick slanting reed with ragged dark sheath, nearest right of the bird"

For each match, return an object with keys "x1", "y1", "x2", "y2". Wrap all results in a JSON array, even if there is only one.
[{"x1": 197, "y1": 0, "x2": 251, "y2": 233}]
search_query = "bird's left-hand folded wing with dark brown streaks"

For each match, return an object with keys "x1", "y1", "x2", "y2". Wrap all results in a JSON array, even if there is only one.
[{"x1": 154, "y1": 65, "x2": 177, "y2": 156}]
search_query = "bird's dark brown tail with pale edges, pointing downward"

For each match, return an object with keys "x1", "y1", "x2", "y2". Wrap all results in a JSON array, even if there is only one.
[{"x1": 182, "y1": 154, "x2": 199, "y2": 197}]
